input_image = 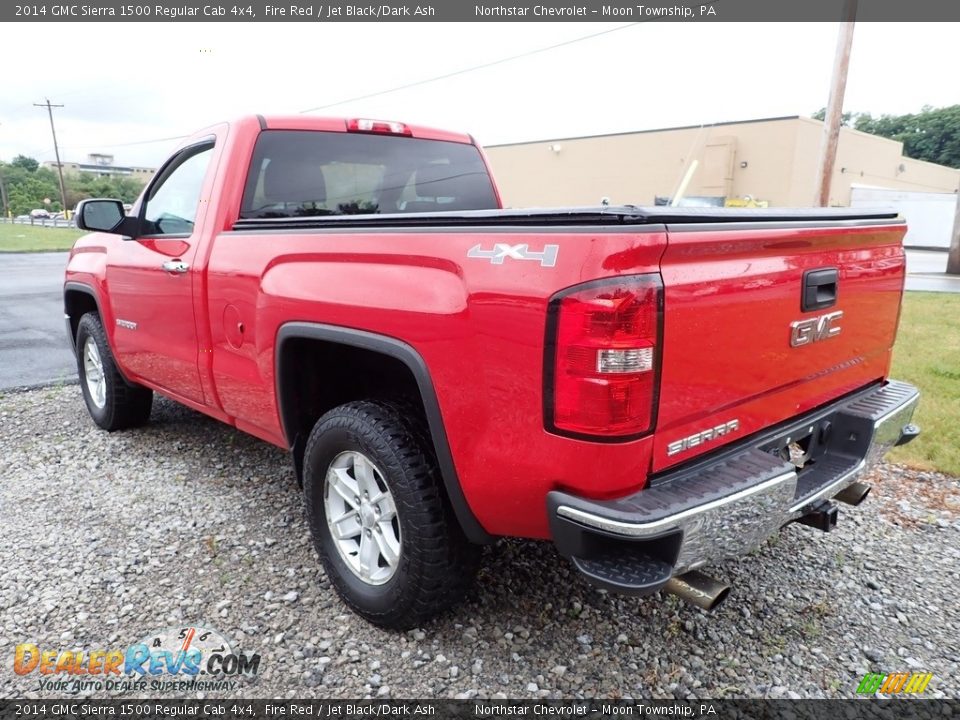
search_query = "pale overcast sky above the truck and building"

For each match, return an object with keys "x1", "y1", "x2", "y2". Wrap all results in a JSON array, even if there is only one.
[{"x1": 0, "y1": 22, "x2": 960, "y2": 165}]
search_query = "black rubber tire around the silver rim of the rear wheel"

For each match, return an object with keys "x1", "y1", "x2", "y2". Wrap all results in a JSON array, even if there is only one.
[{"x1": 303, "y1": 401, "x2": 480, "y2": 630}]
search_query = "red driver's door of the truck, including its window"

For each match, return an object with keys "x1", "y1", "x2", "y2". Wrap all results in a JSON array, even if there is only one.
[{"x1": 107, "y1": 138, "x2": 214, "y2": 403}]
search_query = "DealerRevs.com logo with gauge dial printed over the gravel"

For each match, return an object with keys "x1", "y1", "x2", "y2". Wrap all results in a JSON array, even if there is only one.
[{"x1": 13, "y1": 627, "x2": 260, "y2": 693}]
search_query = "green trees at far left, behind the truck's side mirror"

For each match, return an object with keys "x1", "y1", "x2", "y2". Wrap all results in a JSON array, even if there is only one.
[{"x1": 0, "y1": 155, "x2": 143, "y2": 217}]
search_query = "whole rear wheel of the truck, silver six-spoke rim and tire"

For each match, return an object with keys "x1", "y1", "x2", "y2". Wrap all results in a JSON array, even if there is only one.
[{"x1": 304, "y1": 402, "x2": 479, "y2": 630}]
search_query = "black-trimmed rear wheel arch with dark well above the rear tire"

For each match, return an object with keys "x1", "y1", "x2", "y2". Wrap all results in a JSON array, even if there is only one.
[{"x1": 275, "y1": 322, "x2": 494, "y2": 543}]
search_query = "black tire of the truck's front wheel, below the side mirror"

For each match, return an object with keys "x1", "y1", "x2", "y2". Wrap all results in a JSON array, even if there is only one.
[{"x1": 77, "y1": 312, "x2": 153, "y2": 431}]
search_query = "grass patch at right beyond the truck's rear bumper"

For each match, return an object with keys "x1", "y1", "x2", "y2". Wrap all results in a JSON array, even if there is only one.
[{"x1": 888, "y1": 292, "x2": 960, "y2": 477}]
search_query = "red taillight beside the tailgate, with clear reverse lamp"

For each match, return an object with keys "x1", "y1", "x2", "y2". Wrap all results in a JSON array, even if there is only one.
[{"x1": 545, "y1": 274, "x2": 662, "y2": 437}]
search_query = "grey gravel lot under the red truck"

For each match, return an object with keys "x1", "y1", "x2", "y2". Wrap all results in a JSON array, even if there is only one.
[{"x1": 0, "y1": 386, "x2": 960, "y2": 699}]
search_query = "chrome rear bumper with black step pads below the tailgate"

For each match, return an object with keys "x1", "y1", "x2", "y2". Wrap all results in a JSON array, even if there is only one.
[{"x1": 547, "y1": 381, "x2": 920, "y2": 594}]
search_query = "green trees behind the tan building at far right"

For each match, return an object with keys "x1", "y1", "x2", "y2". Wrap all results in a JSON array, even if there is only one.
[{"x1": 813, "y1": 105, "x2": 960, "y2": 169}]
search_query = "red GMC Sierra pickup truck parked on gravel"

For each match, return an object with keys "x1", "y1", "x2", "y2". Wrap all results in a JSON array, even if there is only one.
[{"x1": 64, "y1": 116, "x2": 919, "y2": 628}]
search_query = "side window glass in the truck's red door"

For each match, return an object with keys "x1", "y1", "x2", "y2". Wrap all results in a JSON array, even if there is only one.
[{"x1": 144, "y1": 145, "x2": 213, "y2": 235}]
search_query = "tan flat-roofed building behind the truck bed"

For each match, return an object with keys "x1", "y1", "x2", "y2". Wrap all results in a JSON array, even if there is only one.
[{"x1": 485, "y1": 117, "x2": 960, "y2": 207}]
